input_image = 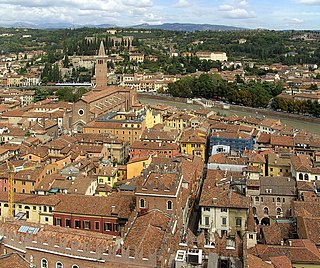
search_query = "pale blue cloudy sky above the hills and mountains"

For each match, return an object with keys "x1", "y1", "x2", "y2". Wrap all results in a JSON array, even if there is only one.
[{"x1": 0, "y1": 0, "x2": 320, "y2": 30}]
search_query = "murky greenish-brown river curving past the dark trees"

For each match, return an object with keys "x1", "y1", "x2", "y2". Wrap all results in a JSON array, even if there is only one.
[{"x1": 139, "y1": 96, "x2": 320, "y2": 135}]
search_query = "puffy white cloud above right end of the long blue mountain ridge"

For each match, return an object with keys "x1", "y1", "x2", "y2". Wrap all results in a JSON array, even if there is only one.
[{"x1": 218, "y1": 1, "x2": 256, "y2": 19}]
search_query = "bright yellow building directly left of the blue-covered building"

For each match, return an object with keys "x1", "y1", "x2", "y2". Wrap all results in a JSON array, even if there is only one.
[{"x1": 180, "y1": 129, "x2": 207, "y2": 161}]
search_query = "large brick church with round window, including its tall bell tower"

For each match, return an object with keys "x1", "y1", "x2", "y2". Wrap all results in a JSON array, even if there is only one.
[{"x1": 72, "y1": 41, "x2": 137, "y2": 132}]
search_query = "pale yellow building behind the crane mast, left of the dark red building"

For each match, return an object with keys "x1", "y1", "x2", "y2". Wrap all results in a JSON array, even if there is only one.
[{"x1": 0, "y1": 192, "x2": 60, "y2": 225}]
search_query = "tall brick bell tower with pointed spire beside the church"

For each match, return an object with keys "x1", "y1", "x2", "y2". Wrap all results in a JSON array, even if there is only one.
[{"x1": 96, "y1": 41, "x2": 108, "y2": 90}]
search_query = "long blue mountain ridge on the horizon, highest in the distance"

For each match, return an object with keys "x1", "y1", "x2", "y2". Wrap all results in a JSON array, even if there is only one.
[{"x1": 131, "y1": 23, "x2": 246, "y2": 32}]
